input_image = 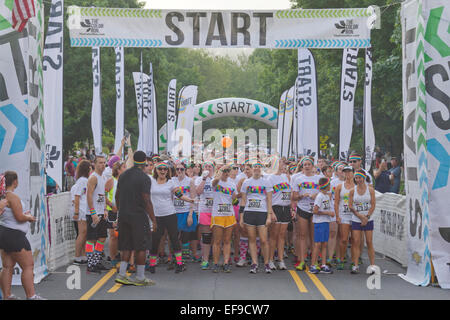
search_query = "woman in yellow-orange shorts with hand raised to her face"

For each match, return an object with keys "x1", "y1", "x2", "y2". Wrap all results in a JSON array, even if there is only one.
[{"x1": 211, "y1": 165, "x2": 237, "y2": 273}]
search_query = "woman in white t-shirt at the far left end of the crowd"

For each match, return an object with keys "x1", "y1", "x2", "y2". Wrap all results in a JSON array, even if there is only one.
[{"x1": 70, "y1": 160, "x2": 91, "y2": 265}]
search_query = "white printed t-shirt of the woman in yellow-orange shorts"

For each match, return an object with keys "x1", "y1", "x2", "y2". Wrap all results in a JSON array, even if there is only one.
[{"x1": 212, "y1": 179, "x2": 236, "y2": 217}]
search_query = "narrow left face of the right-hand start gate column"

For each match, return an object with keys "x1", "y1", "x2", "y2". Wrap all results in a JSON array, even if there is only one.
[{"x1": 401, "y1": 1, "x2": 431, "y2": 286}]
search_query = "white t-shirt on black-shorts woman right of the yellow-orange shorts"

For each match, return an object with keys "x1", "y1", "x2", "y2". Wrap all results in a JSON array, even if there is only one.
[{"x1": 241, "y1": 177, "x2": 273, "y2": 212}]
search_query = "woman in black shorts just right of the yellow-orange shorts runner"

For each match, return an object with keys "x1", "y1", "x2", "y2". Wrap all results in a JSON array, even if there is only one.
[{"x1": 240, "y1": 162, "x2": 276, "y2": 273}]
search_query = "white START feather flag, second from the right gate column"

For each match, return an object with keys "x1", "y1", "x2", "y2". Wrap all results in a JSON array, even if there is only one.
[{"x1": 339, "y1": 48, "x2": 358, "y2": 161}]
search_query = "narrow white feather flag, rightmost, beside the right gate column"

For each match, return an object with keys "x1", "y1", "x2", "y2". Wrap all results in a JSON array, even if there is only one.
[{"x1": 363, "y1": 48, "x2": 375, "y2": 172}]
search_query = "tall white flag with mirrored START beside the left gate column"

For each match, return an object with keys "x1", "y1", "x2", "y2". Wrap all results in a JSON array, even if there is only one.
[{"x1": 42, "y1": 0, "x2": 64, "y2": 186}]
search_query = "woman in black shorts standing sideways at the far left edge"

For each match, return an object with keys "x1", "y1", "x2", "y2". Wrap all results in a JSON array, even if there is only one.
[{"x1": 0, "y1": 171, "x2": 45, "y2": 300}]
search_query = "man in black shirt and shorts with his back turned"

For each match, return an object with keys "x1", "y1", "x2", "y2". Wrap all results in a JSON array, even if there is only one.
[{"x1": 116, "y1": 151, "x2": 156, "y2": 286}]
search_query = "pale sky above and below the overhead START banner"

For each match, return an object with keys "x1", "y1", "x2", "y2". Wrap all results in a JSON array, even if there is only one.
[{"x1": 144, "y1": 0, "x2": 291, "y2": 59}]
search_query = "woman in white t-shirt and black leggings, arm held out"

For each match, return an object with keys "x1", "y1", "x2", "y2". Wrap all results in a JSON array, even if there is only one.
[{"x1": 149, "y1": 162, "x2": 194, "y2": 273}]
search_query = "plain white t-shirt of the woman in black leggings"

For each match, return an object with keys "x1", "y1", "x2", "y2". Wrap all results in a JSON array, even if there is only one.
[{"x1": 150, "y1": 176, "x2": 177, "y2": 217}]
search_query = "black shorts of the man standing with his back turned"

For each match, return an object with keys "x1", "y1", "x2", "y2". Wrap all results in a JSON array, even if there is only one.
[{"x1": 118, "y1": 214, "x2": 151, "y2": 251}]
